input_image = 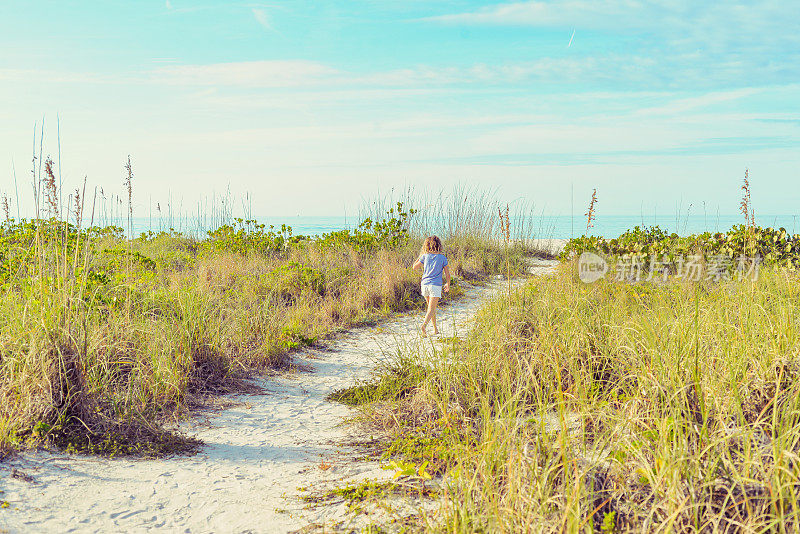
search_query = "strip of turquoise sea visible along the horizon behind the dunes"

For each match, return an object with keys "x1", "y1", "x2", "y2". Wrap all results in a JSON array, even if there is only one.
[{"x1": 123, "y1": 214, "x2": 800, "y2": 238}]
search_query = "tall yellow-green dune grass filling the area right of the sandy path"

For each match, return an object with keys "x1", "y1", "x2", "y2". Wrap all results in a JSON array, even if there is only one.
[{"x1": 350, "y1": 263, "x2": 800, "y2": 532}]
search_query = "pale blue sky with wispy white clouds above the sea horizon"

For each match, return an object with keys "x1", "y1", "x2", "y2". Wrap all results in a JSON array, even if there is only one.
[{"x1": 0, "y1": 0, "x2": 800, "y2": 215}]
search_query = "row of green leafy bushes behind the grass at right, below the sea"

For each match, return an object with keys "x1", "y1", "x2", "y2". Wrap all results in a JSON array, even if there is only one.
[{"x1": 561, "y1": 225, "x2": 800, "y2": 269}]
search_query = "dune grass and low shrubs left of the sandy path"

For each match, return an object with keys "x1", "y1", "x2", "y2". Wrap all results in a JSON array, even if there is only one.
[{"x1": 0, "y1": 191, "x2": 544, "y2": 455}]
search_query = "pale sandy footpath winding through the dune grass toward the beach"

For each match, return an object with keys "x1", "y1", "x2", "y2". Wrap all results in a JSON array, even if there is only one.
[{"x1": 0, "y1": 264, "x2": 548, "y2": 532}]
